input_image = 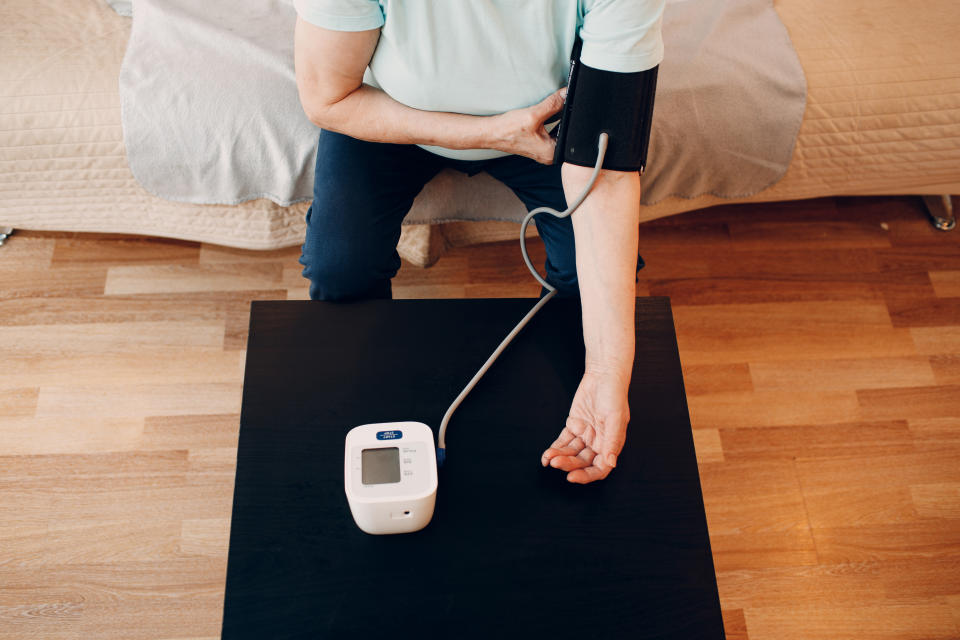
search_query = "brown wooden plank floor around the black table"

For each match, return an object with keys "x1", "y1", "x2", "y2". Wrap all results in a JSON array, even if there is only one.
[{"x1": 0, "y1": 198, "x2": 960, "y2": 640}]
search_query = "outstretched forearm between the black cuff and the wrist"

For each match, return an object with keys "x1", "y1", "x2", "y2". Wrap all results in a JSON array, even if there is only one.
[{"x1": 561, "y1": 164, "x2": 640, "y2": 386}]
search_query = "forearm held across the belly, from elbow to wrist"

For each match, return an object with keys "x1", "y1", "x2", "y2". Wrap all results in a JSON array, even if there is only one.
[{"x1": 305, "y1": 84, "x2": 492, "y2": 149}]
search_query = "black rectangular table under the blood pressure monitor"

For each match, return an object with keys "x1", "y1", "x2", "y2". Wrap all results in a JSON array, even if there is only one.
[{"x1": 223, "y1": 298, "x2": 723, "y2": 640}]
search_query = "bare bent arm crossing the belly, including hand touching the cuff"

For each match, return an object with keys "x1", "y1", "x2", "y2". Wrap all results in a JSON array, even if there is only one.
[{"x1": 294, "y1": 18, "x2": 563, "y2": 164}]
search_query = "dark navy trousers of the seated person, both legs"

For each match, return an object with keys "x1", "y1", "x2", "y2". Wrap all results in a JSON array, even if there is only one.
[{"x1": 300, "y1": 130, "x2": 579, "y2": 300}]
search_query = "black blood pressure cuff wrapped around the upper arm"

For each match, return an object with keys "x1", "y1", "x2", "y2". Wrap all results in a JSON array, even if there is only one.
[{"x1": 553, "y1": 38, "x2": 659, "y2": 174}]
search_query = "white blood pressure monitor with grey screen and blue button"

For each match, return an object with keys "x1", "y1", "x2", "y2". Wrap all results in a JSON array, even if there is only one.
[{"x1": 343, "y1": 422, "x2": 437, "y2": 534}]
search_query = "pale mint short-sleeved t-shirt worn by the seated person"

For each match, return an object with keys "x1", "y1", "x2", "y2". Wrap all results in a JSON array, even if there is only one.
[{"x1": 294, "y1": 0, "x2": 665, "y2": 160}]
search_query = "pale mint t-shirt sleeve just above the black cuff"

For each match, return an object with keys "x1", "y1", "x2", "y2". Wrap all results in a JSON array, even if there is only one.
[{"x1": 580, "y1": 0, "x2": 665, "y2": 73}]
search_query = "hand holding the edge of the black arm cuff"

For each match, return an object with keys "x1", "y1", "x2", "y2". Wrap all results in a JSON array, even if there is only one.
[{"x1": 490, "y1": 87, "x2": 567, "y2": 164}]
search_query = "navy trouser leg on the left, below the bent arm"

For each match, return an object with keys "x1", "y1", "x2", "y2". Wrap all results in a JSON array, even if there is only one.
[{"x1": 300, "y1": 130, "x2": 443, "y2": 300}]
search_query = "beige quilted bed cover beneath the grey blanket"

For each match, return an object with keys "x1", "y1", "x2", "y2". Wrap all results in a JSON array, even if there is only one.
[{"x1": 0, "y1": 0, "x2": 960, "y2": 263}]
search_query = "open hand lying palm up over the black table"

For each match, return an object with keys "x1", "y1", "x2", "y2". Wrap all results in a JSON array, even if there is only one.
[{"x1": 540, "y1": 371, "x2": 630, "y2": 484}]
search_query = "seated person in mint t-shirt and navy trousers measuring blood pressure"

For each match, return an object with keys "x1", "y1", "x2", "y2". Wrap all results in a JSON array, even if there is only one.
[{"x1": 294, "y1": 0, "x2": 664, "y2": 483}]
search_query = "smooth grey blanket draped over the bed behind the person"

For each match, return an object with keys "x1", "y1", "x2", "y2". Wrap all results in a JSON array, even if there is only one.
[{"x1": 120, "y1": 0, "x2": 806, "y2": 210}]
